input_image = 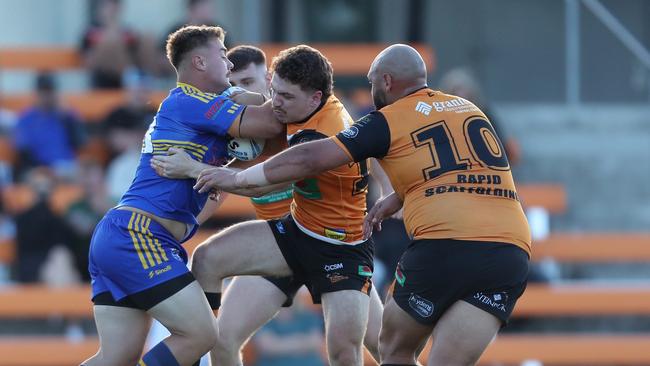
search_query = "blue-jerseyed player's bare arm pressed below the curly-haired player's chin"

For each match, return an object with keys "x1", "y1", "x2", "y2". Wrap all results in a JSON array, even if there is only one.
[{"x1": 228, "y1": 100, "x2": 285, "y2": 139}]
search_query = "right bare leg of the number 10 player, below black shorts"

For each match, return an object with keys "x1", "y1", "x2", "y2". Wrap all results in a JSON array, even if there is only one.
[{"x1": 428, "y1": 301, "x2": 501, "y2": 366}]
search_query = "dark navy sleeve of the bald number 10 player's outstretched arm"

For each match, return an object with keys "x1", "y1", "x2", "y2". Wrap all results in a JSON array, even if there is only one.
[{"x1": 334, "y1": 111, "x2": 390, "y2": 162}]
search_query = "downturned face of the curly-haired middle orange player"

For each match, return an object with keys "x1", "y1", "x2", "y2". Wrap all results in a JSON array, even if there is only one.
[{"x1": 271, "y1": 74, "x2": 323, "y2": 123}]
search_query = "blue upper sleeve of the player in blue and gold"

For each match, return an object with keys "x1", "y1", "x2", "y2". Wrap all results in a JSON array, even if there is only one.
[{"x1": 184, "y1": 94, "x2": 246, "y2": 136}]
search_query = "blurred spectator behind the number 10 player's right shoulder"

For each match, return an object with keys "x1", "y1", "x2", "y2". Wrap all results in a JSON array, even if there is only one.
[{"x1": 440, "y1": 68, "x2": 521, "y2": 167}]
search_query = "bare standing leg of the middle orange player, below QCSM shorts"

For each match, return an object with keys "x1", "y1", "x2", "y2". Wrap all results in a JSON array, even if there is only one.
[{"x1": 322, "y1": 290, "x2": 370, "y2": 366}]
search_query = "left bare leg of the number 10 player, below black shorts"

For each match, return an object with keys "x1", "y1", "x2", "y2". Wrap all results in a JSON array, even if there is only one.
[{"x1": 379, "y1": 298, "x2": 432, "y2": 365}]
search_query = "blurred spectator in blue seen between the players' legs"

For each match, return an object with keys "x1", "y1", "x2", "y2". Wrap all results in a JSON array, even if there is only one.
[{"x1": 253, "y1": 287, "x2": 325, "y2": 366}]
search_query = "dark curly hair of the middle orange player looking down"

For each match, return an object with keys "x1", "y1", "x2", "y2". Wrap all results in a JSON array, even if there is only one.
[{"x1": 271, "y1": 45, "x2": 334, "y2": 100}]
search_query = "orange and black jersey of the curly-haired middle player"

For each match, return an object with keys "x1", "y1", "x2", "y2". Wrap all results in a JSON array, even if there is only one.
[{"x1": 287, "y1": 95, "x2": 368, "y2": 244}]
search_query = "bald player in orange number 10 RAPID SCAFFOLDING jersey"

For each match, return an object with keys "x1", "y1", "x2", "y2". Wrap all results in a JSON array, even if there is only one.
[{"x1": 195, "y1": 45, "x2": 530, "y2": 365}]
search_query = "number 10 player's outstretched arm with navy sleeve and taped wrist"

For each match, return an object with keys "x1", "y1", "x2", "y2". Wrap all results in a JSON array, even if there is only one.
[{"x1": 190, "y1": 112, "x2": 390, "y2": 192}]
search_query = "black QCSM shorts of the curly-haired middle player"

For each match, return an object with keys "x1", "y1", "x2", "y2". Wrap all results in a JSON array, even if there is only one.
[{"x1": 267, "y1": 215, "x2": 374, "y2": 304}]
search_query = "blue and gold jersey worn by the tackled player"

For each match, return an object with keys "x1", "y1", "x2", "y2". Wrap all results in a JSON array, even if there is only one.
[{"x1": 118, "y1": 83, "x2": 246, "y2": 232}]
